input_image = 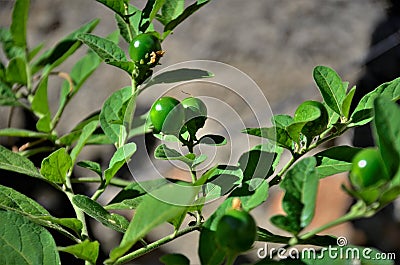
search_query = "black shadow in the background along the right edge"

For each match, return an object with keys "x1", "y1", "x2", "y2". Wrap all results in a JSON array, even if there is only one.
[{"x1": 352, "y1": 0, "x2": 400, "y2": 264}]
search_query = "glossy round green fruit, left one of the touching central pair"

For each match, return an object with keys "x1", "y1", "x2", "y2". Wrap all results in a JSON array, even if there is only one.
[{"x1": 149, "y1": 97, "x2": 185, "y2": 135}]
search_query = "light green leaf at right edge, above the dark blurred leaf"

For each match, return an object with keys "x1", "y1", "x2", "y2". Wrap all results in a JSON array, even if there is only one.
[{"x1": 348, "y1": 78, "x2": 400, "y2": 127}]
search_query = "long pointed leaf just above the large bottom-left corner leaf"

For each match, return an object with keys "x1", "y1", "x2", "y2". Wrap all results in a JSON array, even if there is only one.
[{"x1": 0, "y1": 185, "x2": 82, "y2": 238}]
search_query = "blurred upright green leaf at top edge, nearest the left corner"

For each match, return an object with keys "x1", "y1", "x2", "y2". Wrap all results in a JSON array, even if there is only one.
[{"x1": 10, "y1": 0, "x2": 30, "y2": 48}]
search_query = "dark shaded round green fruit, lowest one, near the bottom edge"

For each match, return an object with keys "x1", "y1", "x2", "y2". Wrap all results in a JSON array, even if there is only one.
[{"x1": 216, "y1": 209, "x2": 257, "y2": 253}]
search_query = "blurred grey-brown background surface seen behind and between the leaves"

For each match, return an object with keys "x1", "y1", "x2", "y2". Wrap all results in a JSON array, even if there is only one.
[{"x1": 0, "y1": 0, "x2": 400, "y2": 264}]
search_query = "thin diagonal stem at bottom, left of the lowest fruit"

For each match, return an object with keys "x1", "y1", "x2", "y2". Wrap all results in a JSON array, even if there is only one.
[{"x1": 113, "y1": 224, "x2": 201, "y2": 265}]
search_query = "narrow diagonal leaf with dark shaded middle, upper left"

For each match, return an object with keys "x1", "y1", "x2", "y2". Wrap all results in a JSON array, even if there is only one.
[{"x1": 32, "y1": 19, "x2": 100, "y2": 75}]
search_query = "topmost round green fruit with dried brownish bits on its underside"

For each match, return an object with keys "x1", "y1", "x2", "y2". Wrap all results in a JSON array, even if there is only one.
[{"x1": 129, "y1": 33, "x2": 162, "y2": 67}]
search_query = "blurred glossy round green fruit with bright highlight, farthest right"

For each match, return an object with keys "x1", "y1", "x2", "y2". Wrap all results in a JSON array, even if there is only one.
[{"x1": 350, "y1": 148, "x2": 389, "y2": 189}]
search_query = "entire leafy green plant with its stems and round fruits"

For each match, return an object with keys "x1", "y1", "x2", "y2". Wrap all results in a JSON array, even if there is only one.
[{"x1": 0, "y1": 0, "x2": 400, "y2": 265}]
